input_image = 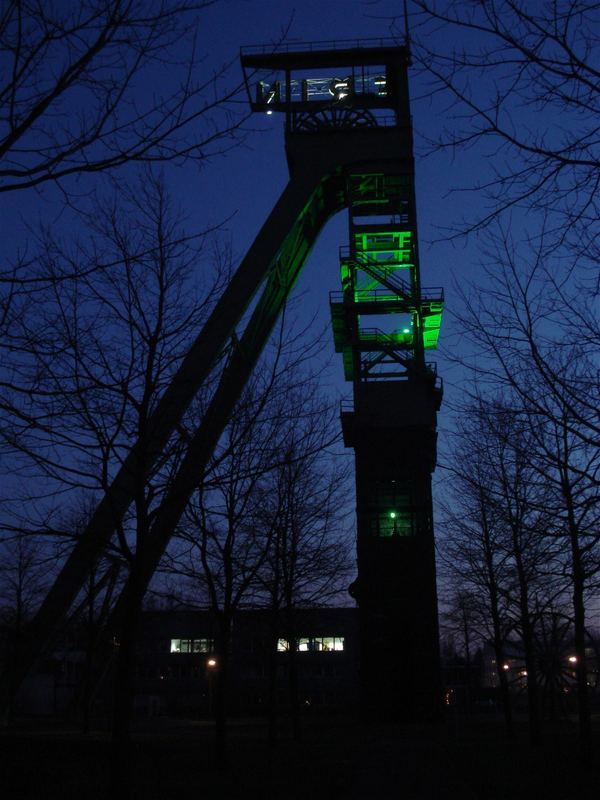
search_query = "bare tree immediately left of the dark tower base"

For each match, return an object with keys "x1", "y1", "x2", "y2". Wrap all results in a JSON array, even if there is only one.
[{"x1": 260, "y1": 382, "x2": 354, "y2": 744}]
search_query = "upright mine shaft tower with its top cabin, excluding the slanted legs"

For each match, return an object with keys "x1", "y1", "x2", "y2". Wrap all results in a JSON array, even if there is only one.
[{"x1": 242, "y1": 37, "x2": 443, "y2": 719}]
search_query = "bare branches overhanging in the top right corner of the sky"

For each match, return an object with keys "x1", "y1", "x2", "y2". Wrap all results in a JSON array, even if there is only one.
[{"x1": 411, "y1": 0, "x2": 600, "y2": 253}]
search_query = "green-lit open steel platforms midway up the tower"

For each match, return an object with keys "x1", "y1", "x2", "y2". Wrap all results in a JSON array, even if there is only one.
[{"x1": 330, "y1": 208, "x2": 444, "y2": 380}]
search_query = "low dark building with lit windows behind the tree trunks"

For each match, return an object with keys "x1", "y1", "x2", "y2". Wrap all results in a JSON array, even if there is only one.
[{"x1": 136, "y1": 608, "x2": 359, "y2": 715}]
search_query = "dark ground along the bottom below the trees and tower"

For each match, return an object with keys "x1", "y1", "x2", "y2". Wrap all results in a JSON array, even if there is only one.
[{"x1": 0, "y1": 715, "x2": 600, "y2": 800}]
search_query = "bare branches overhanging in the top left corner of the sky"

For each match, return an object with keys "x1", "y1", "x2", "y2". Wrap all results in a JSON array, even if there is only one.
[{"x1": 0, "y1": 0, "x2": 244, "y2": 192}]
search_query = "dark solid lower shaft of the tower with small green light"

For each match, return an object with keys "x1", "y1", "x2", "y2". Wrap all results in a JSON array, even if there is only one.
[{"x1": 342, "y1": 380, "x2": 441, "y2": 720}]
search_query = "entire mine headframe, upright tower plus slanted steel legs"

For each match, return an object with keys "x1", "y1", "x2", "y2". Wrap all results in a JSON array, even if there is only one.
[{"x1": 0, "y1": 41, "x2": 441, "y2": 720}]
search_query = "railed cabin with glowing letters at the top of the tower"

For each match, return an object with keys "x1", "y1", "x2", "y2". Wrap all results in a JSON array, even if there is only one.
[{"x1": 241, "y1": 39, "x2": 412, "y2": 172}]
